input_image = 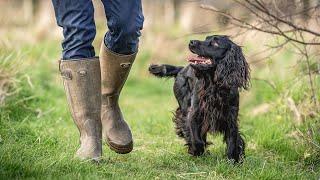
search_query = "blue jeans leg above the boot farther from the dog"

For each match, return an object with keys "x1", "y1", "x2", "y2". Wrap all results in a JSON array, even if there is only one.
[{"x1": 52, "y1": 0, "x2": 96, "y2": 60}]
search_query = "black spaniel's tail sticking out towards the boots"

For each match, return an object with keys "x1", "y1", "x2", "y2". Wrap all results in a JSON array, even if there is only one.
[{"x1": 149, "y1": 64, "x2": 183, "y2": 78}]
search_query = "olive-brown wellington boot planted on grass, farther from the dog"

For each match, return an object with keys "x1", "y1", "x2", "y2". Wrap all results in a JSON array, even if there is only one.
[{"x1": 59, "y1": 58, "x2": 102, "y2": 160}]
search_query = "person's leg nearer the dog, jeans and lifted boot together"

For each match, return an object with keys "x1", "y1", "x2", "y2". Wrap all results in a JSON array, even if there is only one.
[{"x1": 100, "y1": 0, "x2": 144, "y2": 153}]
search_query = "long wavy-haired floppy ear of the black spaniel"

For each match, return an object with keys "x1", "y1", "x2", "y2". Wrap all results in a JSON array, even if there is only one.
[{"x1": 215, "y1": 43, "x2": 250, "y2": 89}]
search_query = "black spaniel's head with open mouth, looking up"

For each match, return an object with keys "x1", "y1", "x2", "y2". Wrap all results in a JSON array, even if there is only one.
[{"x1": 188, "y1": 35, "x2": 250, "y2": 89}]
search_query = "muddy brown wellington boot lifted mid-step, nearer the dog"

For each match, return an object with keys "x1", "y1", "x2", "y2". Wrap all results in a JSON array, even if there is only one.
[{"x1": 100, "y1": 43, "x2": 136, "y2": 154}]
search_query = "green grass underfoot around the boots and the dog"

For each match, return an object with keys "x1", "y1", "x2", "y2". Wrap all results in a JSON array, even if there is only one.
[{"x1": 0, "y1": 42, "x2": 320, "y2": 179}]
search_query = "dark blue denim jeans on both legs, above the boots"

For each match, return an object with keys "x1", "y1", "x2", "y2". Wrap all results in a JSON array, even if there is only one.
[{"x1": 52, "y1": 0, "x2": 144, "y2": 60}]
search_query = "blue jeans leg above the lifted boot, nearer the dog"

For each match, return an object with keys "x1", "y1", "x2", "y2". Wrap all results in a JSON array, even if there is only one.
[{"x1": 102, "y1": 0, "x2": 144, "y2": 55}]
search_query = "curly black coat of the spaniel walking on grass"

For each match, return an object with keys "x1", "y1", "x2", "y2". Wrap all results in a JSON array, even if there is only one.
[{"x1": 149, "y1": 36, "x2": 250, "y2": 162}]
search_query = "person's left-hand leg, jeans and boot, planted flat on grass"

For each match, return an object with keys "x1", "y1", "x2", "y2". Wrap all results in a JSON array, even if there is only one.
[{"x1": 52, "y1": 0, "x2": 102, "y2": 159}]
